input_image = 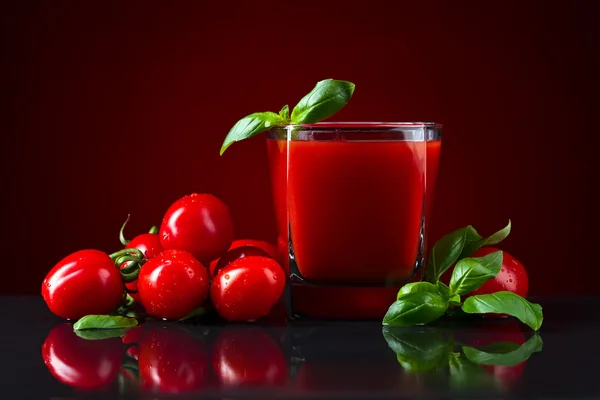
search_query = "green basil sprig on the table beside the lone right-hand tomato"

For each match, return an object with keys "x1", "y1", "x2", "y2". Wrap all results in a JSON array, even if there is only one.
[{"x1": 383, "y1": 220, "x2": 543, "y2": 330}]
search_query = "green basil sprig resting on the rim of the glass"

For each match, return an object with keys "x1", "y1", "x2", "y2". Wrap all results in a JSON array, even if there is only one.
[{"x1": 220, "y1": 79, "x2": 354, "y2": 155}]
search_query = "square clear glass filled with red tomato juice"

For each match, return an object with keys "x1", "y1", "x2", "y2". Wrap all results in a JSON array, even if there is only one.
[{"x1": 267, "y1": 123, "x2": 440, "y2": 318}]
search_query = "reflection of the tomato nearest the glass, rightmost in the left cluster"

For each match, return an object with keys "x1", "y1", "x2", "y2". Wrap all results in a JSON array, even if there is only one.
[{"x1": 211, "y1": 327, "x2": 288, "y2": 386}]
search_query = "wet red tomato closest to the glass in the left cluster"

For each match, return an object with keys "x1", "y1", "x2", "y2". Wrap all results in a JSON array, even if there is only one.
[{"x1": 210, "y1": 256, "x2": 285, "y2": 321}]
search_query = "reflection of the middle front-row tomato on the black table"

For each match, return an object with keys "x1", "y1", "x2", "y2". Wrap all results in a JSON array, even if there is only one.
[{"x1": 139, "y1": 326, "x2": 208, "y2": 393}]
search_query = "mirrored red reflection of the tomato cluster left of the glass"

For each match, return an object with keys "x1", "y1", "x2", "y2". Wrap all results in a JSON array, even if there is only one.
[{"x1": 42, "y1": 323, "x2": 288, "y2": 394}]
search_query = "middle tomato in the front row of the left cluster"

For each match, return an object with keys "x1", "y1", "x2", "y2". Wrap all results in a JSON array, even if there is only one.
[{"x1": 138, "y1": 250, "x2": 209, "y2": 319}]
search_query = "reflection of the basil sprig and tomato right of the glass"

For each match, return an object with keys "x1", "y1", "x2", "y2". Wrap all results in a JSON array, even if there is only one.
[{"x1": 383, "y1": 323, "x2": 542, "y2": 390}]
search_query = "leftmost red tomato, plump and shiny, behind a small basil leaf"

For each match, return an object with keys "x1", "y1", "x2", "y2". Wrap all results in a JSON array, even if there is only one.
[{"x1": 42, "y1": 250, "x2": 124, "y2": 319}]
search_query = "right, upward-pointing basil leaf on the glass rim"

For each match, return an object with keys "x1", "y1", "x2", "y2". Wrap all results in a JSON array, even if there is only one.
[{"x1": 292, "y1": 79, "x2": 354, "y2": 124}]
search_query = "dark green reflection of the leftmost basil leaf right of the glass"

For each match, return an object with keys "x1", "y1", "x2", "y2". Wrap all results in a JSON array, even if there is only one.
[{"x1": 383, "y1": 327, "x2": 450, "y2": 372}]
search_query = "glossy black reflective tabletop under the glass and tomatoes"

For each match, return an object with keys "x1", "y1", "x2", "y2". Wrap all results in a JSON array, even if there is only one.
[{"x1": 0, "y1": 297, "x2": 600, "y2": 399}]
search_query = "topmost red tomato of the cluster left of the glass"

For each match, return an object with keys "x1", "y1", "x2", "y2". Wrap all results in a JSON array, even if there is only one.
[{"x1": 159, "y1": 193, "x2": 233, "y2": 265}]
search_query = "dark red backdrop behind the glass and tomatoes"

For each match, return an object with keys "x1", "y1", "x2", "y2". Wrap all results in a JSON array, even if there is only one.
[{"x1": 0, "y1": 0, "x2": 600, "y2": 295}]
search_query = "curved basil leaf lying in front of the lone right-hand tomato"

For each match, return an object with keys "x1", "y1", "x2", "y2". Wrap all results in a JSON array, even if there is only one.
[{"x1": 462, "y1": 292, "x2": 544, "y2": 331}]
